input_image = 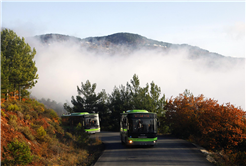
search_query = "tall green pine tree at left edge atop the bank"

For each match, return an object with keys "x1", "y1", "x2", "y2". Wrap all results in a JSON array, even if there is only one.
[{"x1": 0, "y1": 29, "x2": 38, "y2": 100}]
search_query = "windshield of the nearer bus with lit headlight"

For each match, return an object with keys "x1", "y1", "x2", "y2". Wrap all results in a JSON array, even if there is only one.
[{"x1": 129, "y1": 118, "x2": 156, "y2": 133}]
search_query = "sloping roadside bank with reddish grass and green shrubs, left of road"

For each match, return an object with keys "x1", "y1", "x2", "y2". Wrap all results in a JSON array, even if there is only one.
[{"x1": 0, "y1": 95, "x2": 103, "y2": 166}]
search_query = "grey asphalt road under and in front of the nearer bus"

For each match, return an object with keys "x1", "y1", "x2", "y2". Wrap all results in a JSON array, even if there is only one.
[{"x1": 93, "y1": 132, "x2": 214, "y2": 166}]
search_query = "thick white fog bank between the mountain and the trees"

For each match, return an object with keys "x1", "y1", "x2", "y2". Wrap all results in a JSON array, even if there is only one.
[{"x1": 27, "y1": 40, "x2": 245, "y2": 110}]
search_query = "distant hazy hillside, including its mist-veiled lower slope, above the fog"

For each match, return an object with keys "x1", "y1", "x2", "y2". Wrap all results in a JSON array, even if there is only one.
[{"x1": 35, "y1": 33, "x2": 244, "y2": 68}]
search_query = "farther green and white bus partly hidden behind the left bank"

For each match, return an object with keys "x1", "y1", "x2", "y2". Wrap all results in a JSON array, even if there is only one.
[{"x1": 61, "y1": 112, "x2": 100, "y2": 133}]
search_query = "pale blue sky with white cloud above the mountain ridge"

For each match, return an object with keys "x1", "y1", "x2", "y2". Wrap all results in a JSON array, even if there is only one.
[{"x1": 1, "y1": 0, "x2": 245, "y2": 57}]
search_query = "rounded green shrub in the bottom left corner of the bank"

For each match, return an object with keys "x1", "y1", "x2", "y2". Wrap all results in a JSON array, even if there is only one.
[{"x1": 0, "y1": 139, "x2": 33, "y2": 165}]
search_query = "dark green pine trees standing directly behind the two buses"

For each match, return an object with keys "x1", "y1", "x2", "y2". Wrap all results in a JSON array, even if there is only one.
[{"x1": 64, "y1": 74, "x2": 165, "y2": 131}]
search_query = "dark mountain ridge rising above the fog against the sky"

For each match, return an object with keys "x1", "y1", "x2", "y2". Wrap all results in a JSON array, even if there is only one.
[{"x1": 34, "y1": 32, "x2": 244, "y2": 59}]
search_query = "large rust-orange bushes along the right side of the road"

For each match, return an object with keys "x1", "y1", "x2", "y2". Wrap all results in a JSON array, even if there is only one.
[{"x1": 166, "y1": 94, "x2": 246, "y2": 150}]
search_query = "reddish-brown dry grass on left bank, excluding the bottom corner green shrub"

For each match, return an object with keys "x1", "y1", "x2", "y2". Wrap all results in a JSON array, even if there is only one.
[{"x1": 0, "y1": 99, "x2": 104, "y2": 166}]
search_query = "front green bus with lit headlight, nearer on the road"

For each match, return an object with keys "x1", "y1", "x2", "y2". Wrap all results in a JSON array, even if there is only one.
[{"x1": 120, "y1": 110, "x2": 157, "y2": 145}]
